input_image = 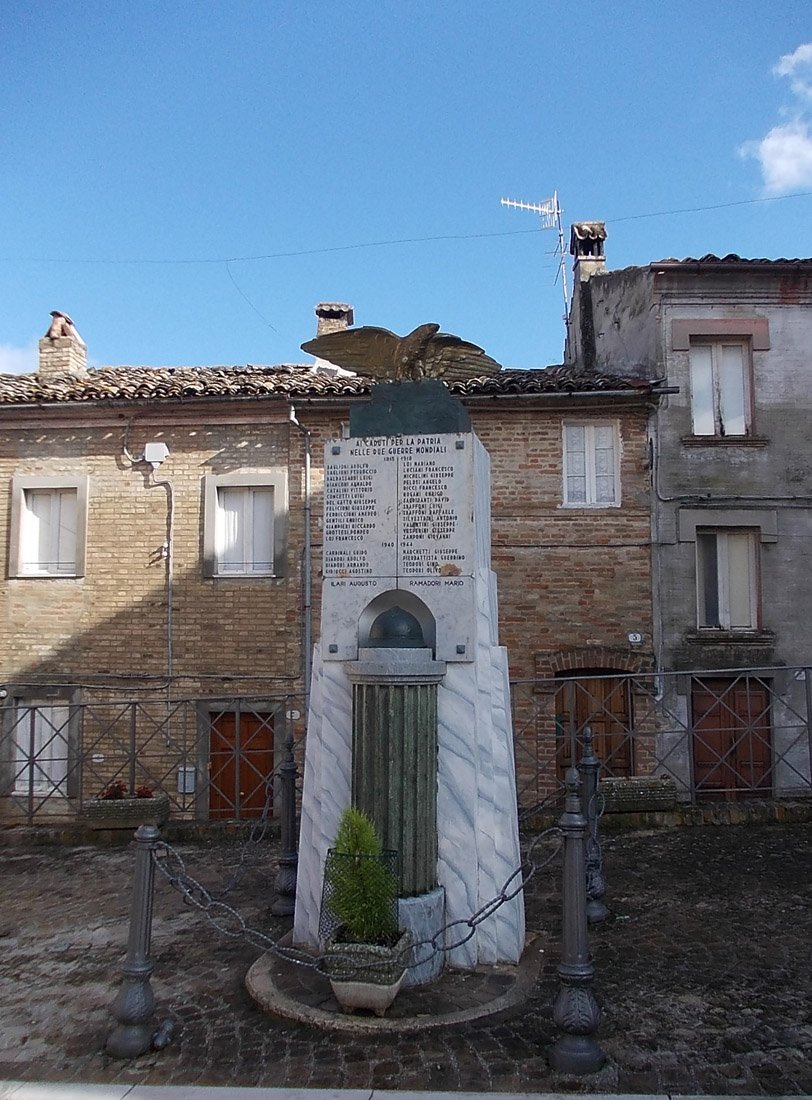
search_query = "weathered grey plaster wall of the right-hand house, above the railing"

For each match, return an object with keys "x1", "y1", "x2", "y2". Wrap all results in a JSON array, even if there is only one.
[{"x1": 656, "y1": 272, "x2": 812, "y2": 668}]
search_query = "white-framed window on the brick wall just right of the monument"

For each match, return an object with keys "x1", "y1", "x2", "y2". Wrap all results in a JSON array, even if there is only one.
[{"x1": 563, "y1": 422, "x2": 621, "y2": 508}]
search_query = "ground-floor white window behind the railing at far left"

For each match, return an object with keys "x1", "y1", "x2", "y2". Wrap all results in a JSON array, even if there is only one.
[{"x1": 10, "y1": 701, "x2": 70, "y2": 795}]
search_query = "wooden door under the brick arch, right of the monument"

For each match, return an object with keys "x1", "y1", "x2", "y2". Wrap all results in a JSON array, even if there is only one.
[{"x1": 556, "y1": 674, "x2": 633, "y2": 779}]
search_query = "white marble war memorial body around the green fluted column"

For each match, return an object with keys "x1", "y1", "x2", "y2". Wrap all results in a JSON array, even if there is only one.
[{"x1": 294, "y1": 431, "x2": 525, "y2": 968}]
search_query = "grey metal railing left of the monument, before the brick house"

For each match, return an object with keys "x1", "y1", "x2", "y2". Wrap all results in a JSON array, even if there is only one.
[{"x1": 0, "y1": 686, "x2": 305, "y2": 824}]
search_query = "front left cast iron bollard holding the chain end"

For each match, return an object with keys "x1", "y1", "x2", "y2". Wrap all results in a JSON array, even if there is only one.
[{"x1": 106, "y1": 825, "x2": 172, "y2": 1058}]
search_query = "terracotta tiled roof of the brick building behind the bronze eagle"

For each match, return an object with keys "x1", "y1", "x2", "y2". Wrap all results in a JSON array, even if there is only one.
[{"x1": 0, "y1": 364, "x2": 649, "y2": 407}]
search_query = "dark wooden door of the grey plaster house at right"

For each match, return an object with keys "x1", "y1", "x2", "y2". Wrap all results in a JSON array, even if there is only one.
[{"x1": 691, "y1": 677, "x2": 771, "y2": 801}]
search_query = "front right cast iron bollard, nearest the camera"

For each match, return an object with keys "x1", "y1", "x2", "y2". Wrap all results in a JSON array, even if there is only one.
[{"x1": 550, "y1": 767, "x2": 606, "y2": 1074}]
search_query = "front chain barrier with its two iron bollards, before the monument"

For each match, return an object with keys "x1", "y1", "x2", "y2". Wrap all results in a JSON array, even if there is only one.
[{"x1": 107, "y1": 730, "x2": 607, "y2": 1074}]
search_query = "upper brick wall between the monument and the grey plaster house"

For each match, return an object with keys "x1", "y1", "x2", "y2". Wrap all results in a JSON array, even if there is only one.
[{"x1": 474, "y1": 408, "x2": 651, "y2": 678}]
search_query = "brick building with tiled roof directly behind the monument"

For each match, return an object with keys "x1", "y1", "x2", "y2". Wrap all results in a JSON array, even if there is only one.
[{"x1": 0, "y1": 305, "x2": 658, "y2": 820}]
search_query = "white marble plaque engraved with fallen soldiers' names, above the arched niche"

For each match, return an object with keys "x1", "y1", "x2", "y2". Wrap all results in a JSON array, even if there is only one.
[{"x1": 321, "y1": 432, "x2": 479, "y2": 661}]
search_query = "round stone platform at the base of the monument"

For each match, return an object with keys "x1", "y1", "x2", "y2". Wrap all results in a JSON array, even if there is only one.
[{"x1": 245, "y1": 933, "x2": 545, "y2": 1034}]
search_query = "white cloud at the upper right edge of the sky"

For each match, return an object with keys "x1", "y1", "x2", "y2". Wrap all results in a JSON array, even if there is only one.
[{"x1": 739, "y1": 42, "x2": 812, "y2": 195}]
